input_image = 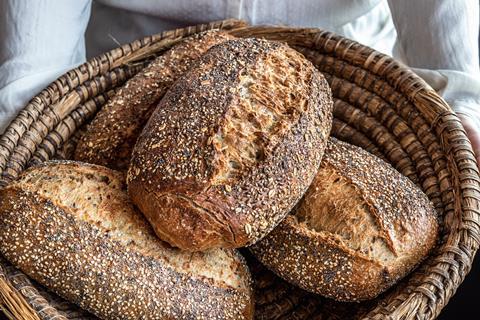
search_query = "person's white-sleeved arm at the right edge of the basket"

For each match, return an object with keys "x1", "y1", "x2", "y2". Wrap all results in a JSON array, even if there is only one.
[{"x1": 389, "y1": 0, "x2": 480, "y2": 160}]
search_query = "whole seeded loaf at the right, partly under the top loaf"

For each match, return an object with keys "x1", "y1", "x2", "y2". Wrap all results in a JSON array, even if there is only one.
[{"x1": 251, "y1": 138, "x2": 438, "y2": 301}]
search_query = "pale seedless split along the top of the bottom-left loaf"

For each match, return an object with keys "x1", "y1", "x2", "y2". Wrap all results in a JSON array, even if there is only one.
[{"x1": 10, "y1": 161, "x2": 249, "y2": 291}]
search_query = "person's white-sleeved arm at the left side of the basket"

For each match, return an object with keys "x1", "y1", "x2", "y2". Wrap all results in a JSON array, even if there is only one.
[{"x1": 0, "y1": 0, "x2": 91, "y2": 133}]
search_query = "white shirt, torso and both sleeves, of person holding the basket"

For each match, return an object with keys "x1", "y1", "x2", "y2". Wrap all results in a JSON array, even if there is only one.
[{"x1": 0, "y1": 0, "x2": 480, "y2": 132}]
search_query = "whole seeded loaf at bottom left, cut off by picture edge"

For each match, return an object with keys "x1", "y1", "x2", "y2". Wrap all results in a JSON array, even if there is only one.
[{"x1": 0, "y1": 162, "x2": 253, "y2": 319}]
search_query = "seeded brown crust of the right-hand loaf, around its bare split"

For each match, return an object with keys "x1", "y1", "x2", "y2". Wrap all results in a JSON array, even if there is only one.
[{"x1": 251, "y1": 138, "x2": 438, "y2": 301}]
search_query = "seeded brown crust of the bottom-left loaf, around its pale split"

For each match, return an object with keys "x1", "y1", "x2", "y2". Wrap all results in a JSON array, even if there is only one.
[{"x1": 0, "y1": 162, "x2": 253, "y2": 319}]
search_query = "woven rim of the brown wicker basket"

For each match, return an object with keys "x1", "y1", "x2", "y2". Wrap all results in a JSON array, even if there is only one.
[{"x1": 0, "y1": 20, "x2": 480, "y2": 319}]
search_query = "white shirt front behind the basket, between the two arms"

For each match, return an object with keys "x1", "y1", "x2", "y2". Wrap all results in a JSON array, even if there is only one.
[{"x1": 86, "y1": 0, "x2": 396, "y2": 57}]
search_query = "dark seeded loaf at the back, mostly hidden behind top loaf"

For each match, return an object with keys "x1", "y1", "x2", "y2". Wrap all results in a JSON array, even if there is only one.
[{"x1": 74, "y1": 30, "x2": 234, "y2": 171}]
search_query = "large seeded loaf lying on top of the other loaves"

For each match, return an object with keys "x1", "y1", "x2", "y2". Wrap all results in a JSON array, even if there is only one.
[{"x1": 127, "y1": 39, "x2": 332, "y2": 251}]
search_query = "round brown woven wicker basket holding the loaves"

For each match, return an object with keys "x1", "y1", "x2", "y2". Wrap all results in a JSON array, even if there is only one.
[{"x1": 0, "y1": 20, "x2": 480, "y2": 320}]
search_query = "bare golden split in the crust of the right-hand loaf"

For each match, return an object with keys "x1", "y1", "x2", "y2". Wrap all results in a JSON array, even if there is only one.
[{"x1": 293, "y1": 162, "x2": 395, "y2": 261}]
